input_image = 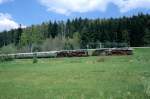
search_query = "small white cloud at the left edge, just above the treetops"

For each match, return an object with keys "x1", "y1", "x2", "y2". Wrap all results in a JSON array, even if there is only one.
[{"x1": 0, "y1": 13, "x2": 25, "y2": 31}]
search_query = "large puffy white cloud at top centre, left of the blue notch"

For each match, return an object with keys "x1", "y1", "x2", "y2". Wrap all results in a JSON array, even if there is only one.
[{"x1": 40, "y1": 0, "x2": 108, "y2": 14}]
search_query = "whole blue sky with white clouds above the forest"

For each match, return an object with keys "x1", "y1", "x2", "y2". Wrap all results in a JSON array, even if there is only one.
[{"x1": 0, "y1": 0, "x2": 150, "y2": 31}]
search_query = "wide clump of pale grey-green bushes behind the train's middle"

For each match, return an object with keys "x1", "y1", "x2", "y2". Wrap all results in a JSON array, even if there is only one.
[{"x1": 41, "y1": 33, "x2": 80, "y2": 51}]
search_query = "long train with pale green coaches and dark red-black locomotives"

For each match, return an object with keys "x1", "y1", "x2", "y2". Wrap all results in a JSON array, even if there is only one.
[{"x1": 0, "y1": 48, "x2": 133, "y2": 59}]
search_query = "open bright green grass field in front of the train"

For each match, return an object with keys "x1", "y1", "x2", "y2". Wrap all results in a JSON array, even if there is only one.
[{"x1": 0, "y1": 49, "x2": 150, "y2": 99}]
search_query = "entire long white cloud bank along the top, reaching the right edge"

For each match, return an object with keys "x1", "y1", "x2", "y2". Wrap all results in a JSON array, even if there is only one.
[{"x1": 39, "y1": 0, "x2": 150, "y2": 15}]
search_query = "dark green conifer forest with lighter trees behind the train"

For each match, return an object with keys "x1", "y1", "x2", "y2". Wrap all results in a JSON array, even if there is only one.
[{"x1": 0, "y1": 13, "x2": 150, "y2": 50}]
